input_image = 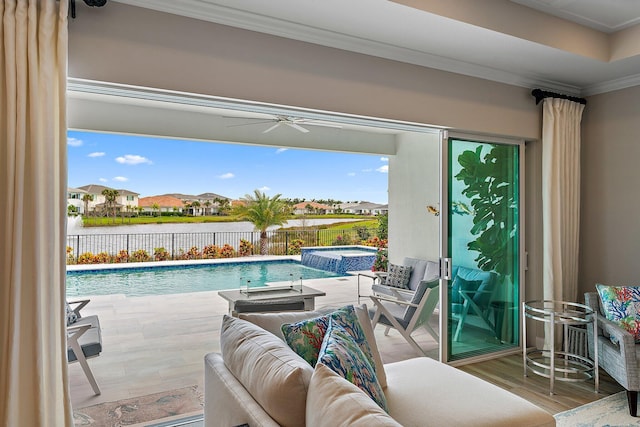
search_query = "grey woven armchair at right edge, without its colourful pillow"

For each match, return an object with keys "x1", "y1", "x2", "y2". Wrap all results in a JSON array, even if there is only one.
[{"x1": 584, "y1": 292, "x2": 640, "y2": 417}]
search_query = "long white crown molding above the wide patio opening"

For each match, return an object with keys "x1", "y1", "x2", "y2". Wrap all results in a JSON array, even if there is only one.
[{"x1": 113, "y1": 0, "x2": 581, "y2": 96}]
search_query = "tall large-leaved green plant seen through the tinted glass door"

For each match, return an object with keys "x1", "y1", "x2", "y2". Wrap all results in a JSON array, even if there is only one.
[{"x1": 455, "y1": 145, "x2": 518, "y2": 276}]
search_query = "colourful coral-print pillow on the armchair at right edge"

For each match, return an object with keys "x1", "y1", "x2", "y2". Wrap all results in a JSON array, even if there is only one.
[{"x1": 596, "y1": 284, "x2": 640, "y2": 343}]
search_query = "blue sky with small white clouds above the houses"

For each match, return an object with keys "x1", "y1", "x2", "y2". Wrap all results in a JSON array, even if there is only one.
[{"x1": 67, "y1": 131, "x2": 389, "y2": 204}]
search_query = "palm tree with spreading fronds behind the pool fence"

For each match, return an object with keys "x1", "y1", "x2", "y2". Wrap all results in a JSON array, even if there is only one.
[{"x1": 235, "y1": 190, "x2": 291, "y2": 255}]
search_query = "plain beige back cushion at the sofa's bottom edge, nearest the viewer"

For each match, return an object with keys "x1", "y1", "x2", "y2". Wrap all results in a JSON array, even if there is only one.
[{"x1": 306, "y1": 363, "x2": 401, "y2": 427}]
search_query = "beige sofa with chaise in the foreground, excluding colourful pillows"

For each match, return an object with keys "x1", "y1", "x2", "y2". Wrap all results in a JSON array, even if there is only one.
[{"x1": 204, "y1": 306, "x2": 555, "y2": 427}]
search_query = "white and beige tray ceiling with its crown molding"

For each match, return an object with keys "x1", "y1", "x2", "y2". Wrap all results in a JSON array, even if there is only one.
[{"x1": 114, "y1": 0, "x2": 640, "y2": 96}]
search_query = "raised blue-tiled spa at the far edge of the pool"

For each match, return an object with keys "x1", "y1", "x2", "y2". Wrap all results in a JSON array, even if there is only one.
[{"x1": 302, "y1": 246, "x2": 377, "y2": 274}]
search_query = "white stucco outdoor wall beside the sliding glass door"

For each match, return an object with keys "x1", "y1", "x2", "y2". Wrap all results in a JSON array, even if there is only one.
[{"x1": 389, "y1": 133, "x2": 440, "y2": 263}]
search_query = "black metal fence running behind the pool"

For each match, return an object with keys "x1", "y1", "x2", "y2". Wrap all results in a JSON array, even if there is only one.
[{"x1": 67, "y1": 227, "x2": 377, "y2": 264}]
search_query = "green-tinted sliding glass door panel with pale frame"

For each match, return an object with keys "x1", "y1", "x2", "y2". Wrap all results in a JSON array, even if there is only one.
[{"x1": 441, "y1": 133, "x2": 524, "y2": 362}]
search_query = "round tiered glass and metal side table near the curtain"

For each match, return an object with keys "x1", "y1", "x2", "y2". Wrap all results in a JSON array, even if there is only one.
[{"x1": 522, "y1": 300, "x2": 599, "y2": 395}]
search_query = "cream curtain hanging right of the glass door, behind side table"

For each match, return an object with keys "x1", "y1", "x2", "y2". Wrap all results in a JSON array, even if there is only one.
[{"x1": 542, "y1": 98, "x2": 584, "y2": 302}]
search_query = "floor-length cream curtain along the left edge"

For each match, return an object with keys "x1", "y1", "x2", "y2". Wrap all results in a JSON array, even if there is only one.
[{"x1": 0, "y1": 0, "x2": 73, "y2": 427}]
